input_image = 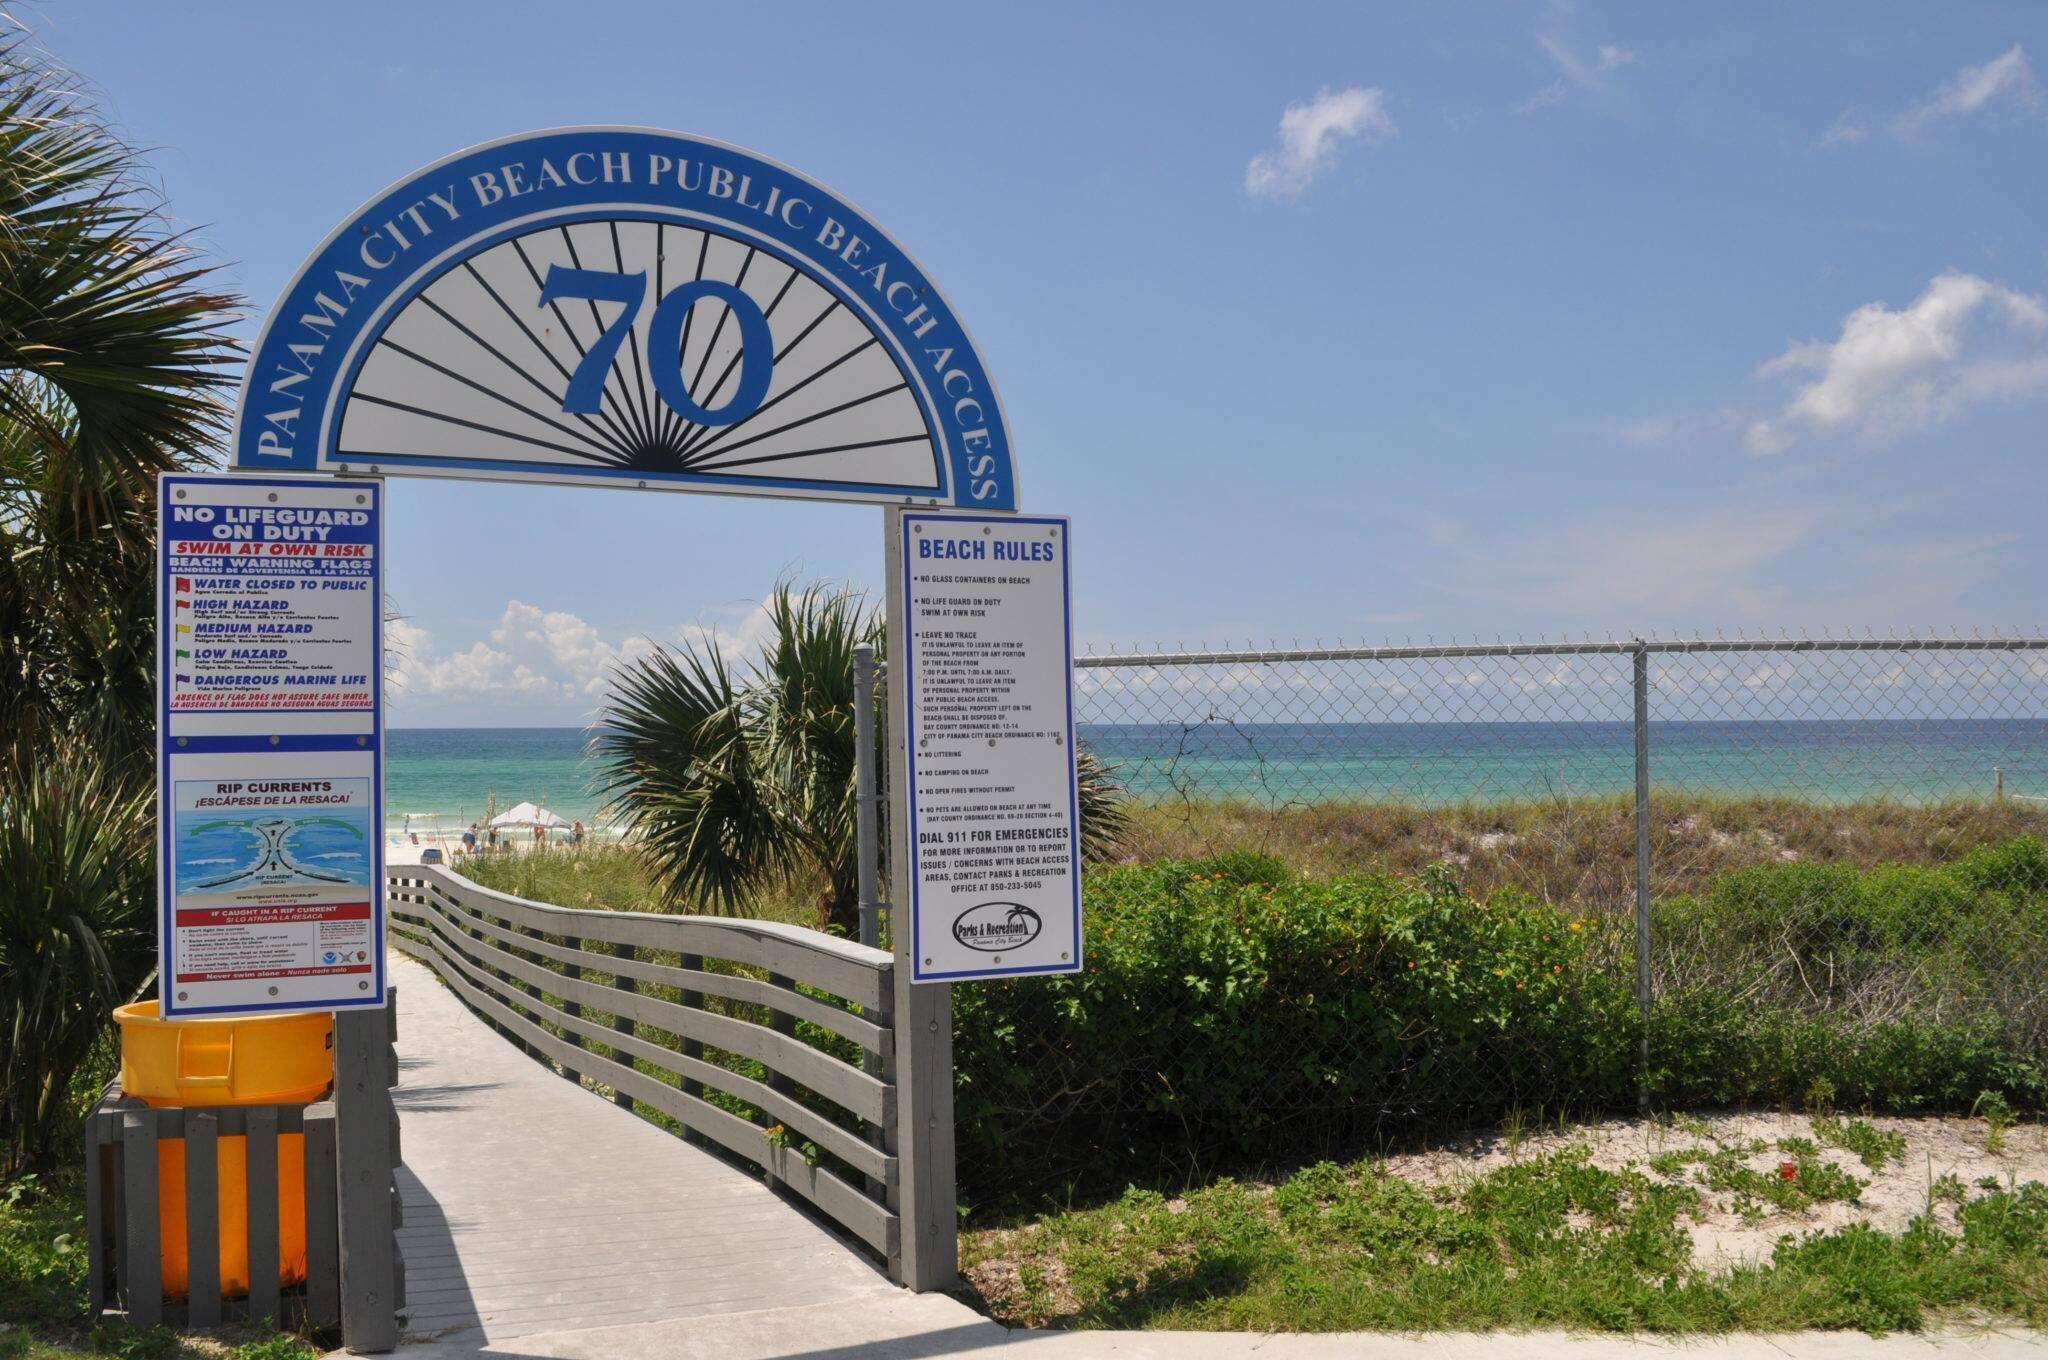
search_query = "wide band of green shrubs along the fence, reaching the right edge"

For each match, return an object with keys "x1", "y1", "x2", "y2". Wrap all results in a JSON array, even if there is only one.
[{"x1": 954, "y1": 840, "x2": 2048, "y2": 1206}]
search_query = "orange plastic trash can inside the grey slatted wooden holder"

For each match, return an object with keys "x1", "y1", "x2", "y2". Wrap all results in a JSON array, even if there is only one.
[{"x1": 115, "y1": 1002, "x2": 334, "y2": 1299}]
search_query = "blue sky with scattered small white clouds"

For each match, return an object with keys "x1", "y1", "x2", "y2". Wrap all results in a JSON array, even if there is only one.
[{"x1": 29, "y1": 0, "x2": 2048, "y2": 723}]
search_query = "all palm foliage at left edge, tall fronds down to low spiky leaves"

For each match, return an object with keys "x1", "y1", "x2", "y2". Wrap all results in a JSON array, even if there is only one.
[{"x1": 0, "y1": 14, "x2": 233, "y2": 1174}]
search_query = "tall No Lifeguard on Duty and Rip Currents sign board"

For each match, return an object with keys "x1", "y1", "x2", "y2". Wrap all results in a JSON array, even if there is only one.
[{"x1": 156, "y1": 475, "x2": 385, "y2": 1016}]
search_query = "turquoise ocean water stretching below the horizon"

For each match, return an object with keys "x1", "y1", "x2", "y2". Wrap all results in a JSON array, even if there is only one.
[{"x1": 385, "y1": 719, "x2": 2048, "y2": 834}]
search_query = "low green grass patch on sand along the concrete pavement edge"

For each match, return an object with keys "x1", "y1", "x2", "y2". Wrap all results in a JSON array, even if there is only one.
[{"x1": 963, "y1": 1149, "x2": 2048, "y2": 1333}]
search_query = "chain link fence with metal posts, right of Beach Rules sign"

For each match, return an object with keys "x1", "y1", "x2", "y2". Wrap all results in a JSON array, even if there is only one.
[{"x1": 950, "y1": 637, "x2": 2048, "y2": 1196}]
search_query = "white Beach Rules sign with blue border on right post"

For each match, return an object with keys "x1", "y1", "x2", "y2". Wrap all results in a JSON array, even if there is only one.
[{"x1": 891, "y1": 510, "x2": 1081, "y2": 983}]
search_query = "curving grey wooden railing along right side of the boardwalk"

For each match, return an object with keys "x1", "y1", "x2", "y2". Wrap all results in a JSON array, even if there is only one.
[{"x1": 385, "y1": 864, "x2": 903, "y2": 1280}]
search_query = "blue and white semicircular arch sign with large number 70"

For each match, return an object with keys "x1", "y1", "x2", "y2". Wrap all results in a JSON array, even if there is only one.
[{"x1": 233, "y1": 127, "x2": 1016, "y2": 510}]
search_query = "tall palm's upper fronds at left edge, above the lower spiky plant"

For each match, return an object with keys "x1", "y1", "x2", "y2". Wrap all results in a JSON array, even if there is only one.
[{"x1": 0, "y1": 26, "x2": 236, "y2": 772}]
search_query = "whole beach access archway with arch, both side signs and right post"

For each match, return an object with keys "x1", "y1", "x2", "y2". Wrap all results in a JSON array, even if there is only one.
[{"x1": 192, "y1": 127, "x2": 1081, "y2": 1288}]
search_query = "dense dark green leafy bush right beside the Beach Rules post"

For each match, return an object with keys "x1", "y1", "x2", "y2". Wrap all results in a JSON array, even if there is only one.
[{"x1": 954, "y1": 856, "x2": 1632, "y2": 1202}]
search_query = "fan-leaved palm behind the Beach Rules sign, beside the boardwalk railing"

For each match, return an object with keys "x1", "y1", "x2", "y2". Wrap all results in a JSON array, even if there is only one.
[{"x1": 592, "y1": 584, "x2": 1124, "y2": 934}]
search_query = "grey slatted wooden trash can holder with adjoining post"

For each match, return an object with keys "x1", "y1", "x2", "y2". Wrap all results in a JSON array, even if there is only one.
[{"x1": 86, "y1": 989, "x2": 406, "y2": 1352}]
